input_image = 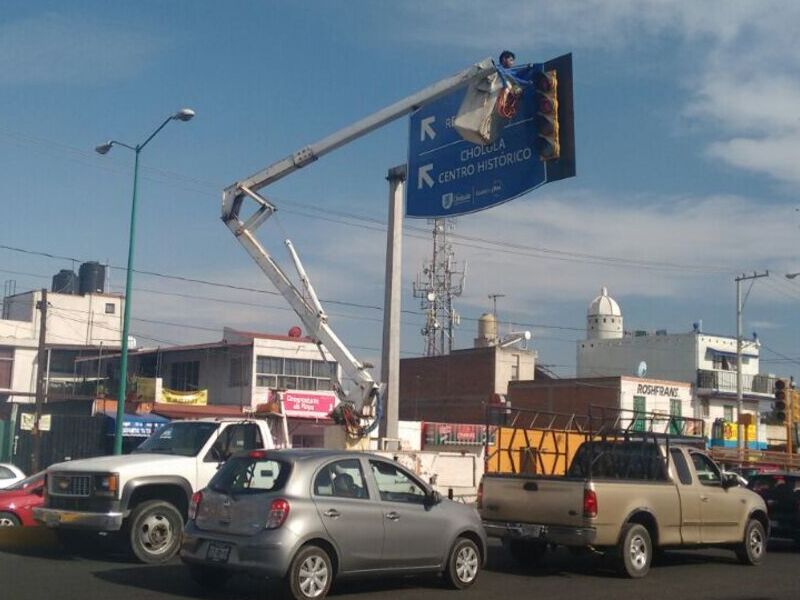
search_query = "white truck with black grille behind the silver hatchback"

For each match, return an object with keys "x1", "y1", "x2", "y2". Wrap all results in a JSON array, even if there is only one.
[{"x1": 34, "y1": 416, "x2": 286, "y2": 563}]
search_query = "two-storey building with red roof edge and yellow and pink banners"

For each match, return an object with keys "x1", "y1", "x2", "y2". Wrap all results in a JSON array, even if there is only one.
[{"x1": 79, "y1": 328, "x2": 339, "y2": 447}]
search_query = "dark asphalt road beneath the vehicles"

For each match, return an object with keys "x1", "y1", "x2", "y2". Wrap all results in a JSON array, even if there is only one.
[{"x1": 0, "y1": 532, "x2": 800, "y2": 600}]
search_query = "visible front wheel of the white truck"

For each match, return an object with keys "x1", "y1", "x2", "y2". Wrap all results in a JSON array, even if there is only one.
[{"x1": 128, "y1": 500, "x2": 183, "y2": 564}]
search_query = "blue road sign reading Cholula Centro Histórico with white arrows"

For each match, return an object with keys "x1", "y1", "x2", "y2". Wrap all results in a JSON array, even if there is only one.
[{"x1": 406, "y1": 65, "x2": 546, "y2": 218}]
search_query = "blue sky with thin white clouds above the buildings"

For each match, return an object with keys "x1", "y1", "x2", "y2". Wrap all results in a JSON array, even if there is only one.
[{"x1": 0, "y1": 0, "x2": 800, "y2": 375}]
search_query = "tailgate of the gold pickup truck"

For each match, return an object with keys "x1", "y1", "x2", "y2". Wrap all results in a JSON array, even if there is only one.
[{"x1": 480, "y1": 475, "x2": 586, "y2": 527}]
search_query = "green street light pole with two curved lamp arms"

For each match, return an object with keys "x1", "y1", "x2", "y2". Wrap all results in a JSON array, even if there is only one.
[{"x1": 95, "y1": 108, "x2": 195, "y2": 454}]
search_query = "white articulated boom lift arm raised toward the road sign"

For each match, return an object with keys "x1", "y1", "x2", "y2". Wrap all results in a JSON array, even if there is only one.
[{"x1": 222, "y1": 58, "x2": 496, "y2": 438}]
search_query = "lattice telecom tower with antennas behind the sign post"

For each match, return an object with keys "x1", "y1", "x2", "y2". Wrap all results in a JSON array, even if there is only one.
[{"x1": 414, "y1": 219, "x2": 467, "y2": 356}]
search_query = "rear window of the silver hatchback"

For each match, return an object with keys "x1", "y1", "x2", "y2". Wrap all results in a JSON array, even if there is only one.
[{"x1": 208, "y1": 456, "x2": 291, "y2": 495}]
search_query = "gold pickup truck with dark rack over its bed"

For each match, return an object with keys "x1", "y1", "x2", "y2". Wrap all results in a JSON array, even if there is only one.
[{"x1": 478, "y1": 439, "x2": 769, "y2": 578}]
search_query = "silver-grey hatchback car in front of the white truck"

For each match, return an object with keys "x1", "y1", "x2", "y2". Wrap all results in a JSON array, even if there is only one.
[{"x1": 180, "y1": 449, "x2": 487, "y2": 600}]
